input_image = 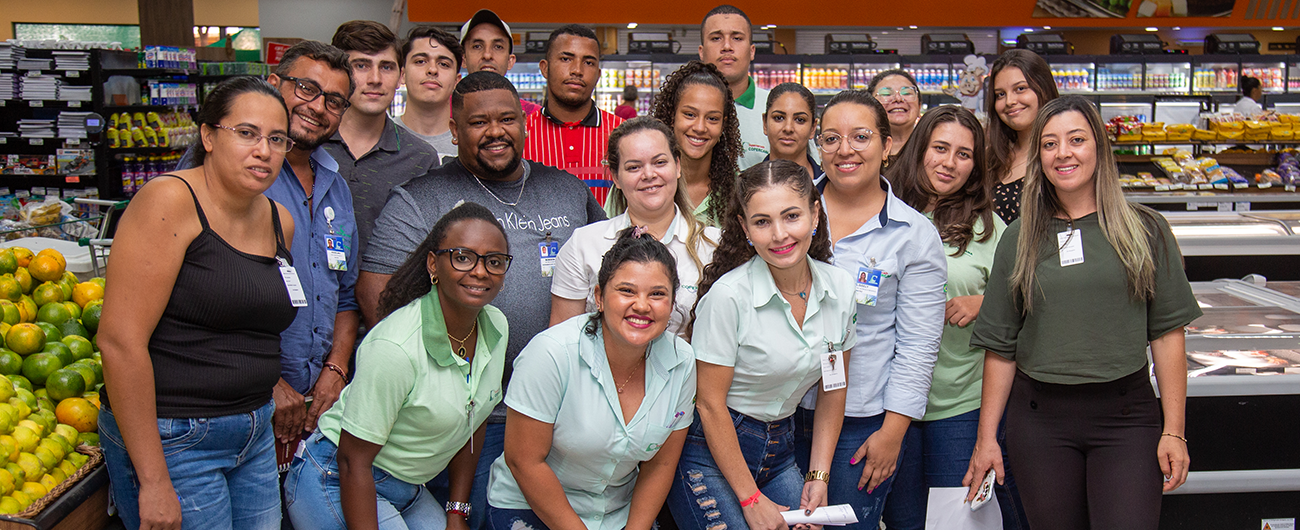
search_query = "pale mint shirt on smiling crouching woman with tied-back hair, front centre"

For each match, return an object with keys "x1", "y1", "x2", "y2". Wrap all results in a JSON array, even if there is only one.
[{"x1": 488, "y1": 313, "x2": 696, "y2": 530}]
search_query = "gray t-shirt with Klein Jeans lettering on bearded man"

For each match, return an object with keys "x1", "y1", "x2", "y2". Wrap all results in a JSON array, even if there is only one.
[{"x1": 361, "y1": 158, "x2": 605, "y2": 417}]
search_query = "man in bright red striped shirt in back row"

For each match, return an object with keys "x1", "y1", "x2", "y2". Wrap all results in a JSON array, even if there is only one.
[{"x1": 524, "y1": 23, "x2": 623, "y2": 204}]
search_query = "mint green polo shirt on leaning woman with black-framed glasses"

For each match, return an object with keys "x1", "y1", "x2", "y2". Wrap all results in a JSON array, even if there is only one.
[{"x1": 319, "y1": 290, "x2": 508, "y2": 485}]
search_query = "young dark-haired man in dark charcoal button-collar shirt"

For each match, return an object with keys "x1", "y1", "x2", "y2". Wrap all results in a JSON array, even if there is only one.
[{"x1": 324, "y1": 21, "x2": 439, "y2": 262}]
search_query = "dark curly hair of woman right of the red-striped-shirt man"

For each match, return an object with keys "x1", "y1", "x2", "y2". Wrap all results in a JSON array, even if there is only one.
[{"x1": 650, "y1": 61, "x2": 741, "y2": 222}]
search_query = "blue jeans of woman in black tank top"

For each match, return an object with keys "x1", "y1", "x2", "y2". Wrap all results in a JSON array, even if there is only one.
[{"x1": 99, "y1": 401, "x2": 280, "y2": 530}]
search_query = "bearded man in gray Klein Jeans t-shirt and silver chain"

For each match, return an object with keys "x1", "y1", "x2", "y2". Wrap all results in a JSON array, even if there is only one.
[{"x1": 356, "y1": 71, "x2": 605, "y2": 529}]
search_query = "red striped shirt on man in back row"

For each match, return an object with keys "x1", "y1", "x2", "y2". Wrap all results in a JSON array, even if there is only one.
[{"x1": 524, "y1": 104, "x2": 623, "y2": 204}]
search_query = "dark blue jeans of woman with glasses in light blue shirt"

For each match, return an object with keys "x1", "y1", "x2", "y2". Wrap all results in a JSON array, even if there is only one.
[{"x1": 794, "y1": 408, "x2": 906, "y2": 530}]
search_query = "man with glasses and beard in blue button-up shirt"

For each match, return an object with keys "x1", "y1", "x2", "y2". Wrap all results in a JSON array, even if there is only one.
[{"x1": 177, "y1": 40, "x2": 360, "y2": 452}]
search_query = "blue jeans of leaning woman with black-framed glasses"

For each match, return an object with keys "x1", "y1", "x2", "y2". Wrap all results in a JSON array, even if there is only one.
[{"x1": 285, "y1": 431, "x2": 447, "y2": 530}]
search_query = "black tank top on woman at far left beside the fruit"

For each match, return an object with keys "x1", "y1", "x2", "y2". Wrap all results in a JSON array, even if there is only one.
[{"x1": 111, "y1": 175, "x2": 298, "y2": 418}]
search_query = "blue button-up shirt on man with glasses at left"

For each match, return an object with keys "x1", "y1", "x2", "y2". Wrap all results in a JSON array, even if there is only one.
[{"x1": 265, "y1": 148, "x2": 360, "y2": 394}]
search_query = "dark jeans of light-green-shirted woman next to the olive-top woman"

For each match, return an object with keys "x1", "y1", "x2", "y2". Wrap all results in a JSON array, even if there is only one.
[{"x1": 884, "y1": 409, "x2": 983, "y2": 530}]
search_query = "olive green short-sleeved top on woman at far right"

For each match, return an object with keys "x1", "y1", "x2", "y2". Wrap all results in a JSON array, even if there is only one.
[{"x1": 971, "y1": 210, "x2": 1201, "y2": 385}]
